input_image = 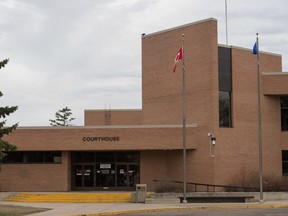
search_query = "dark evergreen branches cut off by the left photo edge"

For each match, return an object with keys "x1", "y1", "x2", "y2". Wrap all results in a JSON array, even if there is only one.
[{"x1": 0, "y1": 59, "x2": 18, "y2": 161}]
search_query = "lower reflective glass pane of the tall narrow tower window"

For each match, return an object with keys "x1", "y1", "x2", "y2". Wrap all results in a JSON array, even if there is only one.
[{"x1": 219, "y1": 91, "x2": 232, "y2": 127}]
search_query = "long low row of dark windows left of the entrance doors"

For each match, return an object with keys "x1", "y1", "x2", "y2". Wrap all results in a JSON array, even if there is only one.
[{"x1": 3, "y1": 151, "x2": 62, "y2": 163}]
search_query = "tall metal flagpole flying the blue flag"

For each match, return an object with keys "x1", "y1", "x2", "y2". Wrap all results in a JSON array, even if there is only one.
[{"x1": 256, "y1": 33, "x2": 264, "y2": 205}]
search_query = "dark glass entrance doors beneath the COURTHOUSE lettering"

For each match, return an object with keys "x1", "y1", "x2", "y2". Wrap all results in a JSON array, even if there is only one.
[{"x1": 71, "y1": 152, "x2": 140, "y2": 190}]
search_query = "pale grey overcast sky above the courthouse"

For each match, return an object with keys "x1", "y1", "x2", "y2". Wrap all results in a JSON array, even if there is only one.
[{"x1": 0, "y1": 0, "x2": 288, "y2": 126}]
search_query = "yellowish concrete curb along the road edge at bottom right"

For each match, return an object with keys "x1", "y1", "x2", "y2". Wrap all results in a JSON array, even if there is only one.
[{"x1": 71, "y1": 204, "x2": 288, "y2": 216}]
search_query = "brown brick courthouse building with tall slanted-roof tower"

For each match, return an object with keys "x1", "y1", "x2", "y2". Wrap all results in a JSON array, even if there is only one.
[{"x1": 0, "y1": 18, "x2": 288, "y2": 191}]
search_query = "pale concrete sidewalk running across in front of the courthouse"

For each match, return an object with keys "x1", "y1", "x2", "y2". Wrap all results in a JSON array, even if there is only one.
[{"x1": 0, "y1": 200, "x2": 288, "y2": 216}]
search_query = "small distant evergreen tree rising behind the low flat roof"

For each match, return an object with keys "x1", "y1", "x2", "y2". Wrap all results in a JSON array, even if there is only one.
[{"x1": 49, "y1": 106, "x2": 75, "y2": 127}]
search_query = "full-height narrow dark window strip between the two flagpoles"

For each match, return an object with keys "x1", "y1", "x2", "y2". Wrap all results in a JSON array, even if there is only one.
[{"x1": 218, "y1": 46, "x2": 232, "y2": 127}]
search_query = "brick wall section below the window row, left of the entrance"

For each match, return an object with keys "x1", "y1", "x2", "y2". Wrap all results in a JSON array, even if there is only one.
[{"x1": 0, "y1": 152, "x2": 70, "y2": 191}]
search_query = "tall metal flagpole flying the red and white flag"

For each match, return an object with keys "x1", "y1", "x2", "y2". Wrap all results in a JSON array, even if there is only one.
[{"x1": 182, "y1": 34, "x2": 187, "y2": 203}]
